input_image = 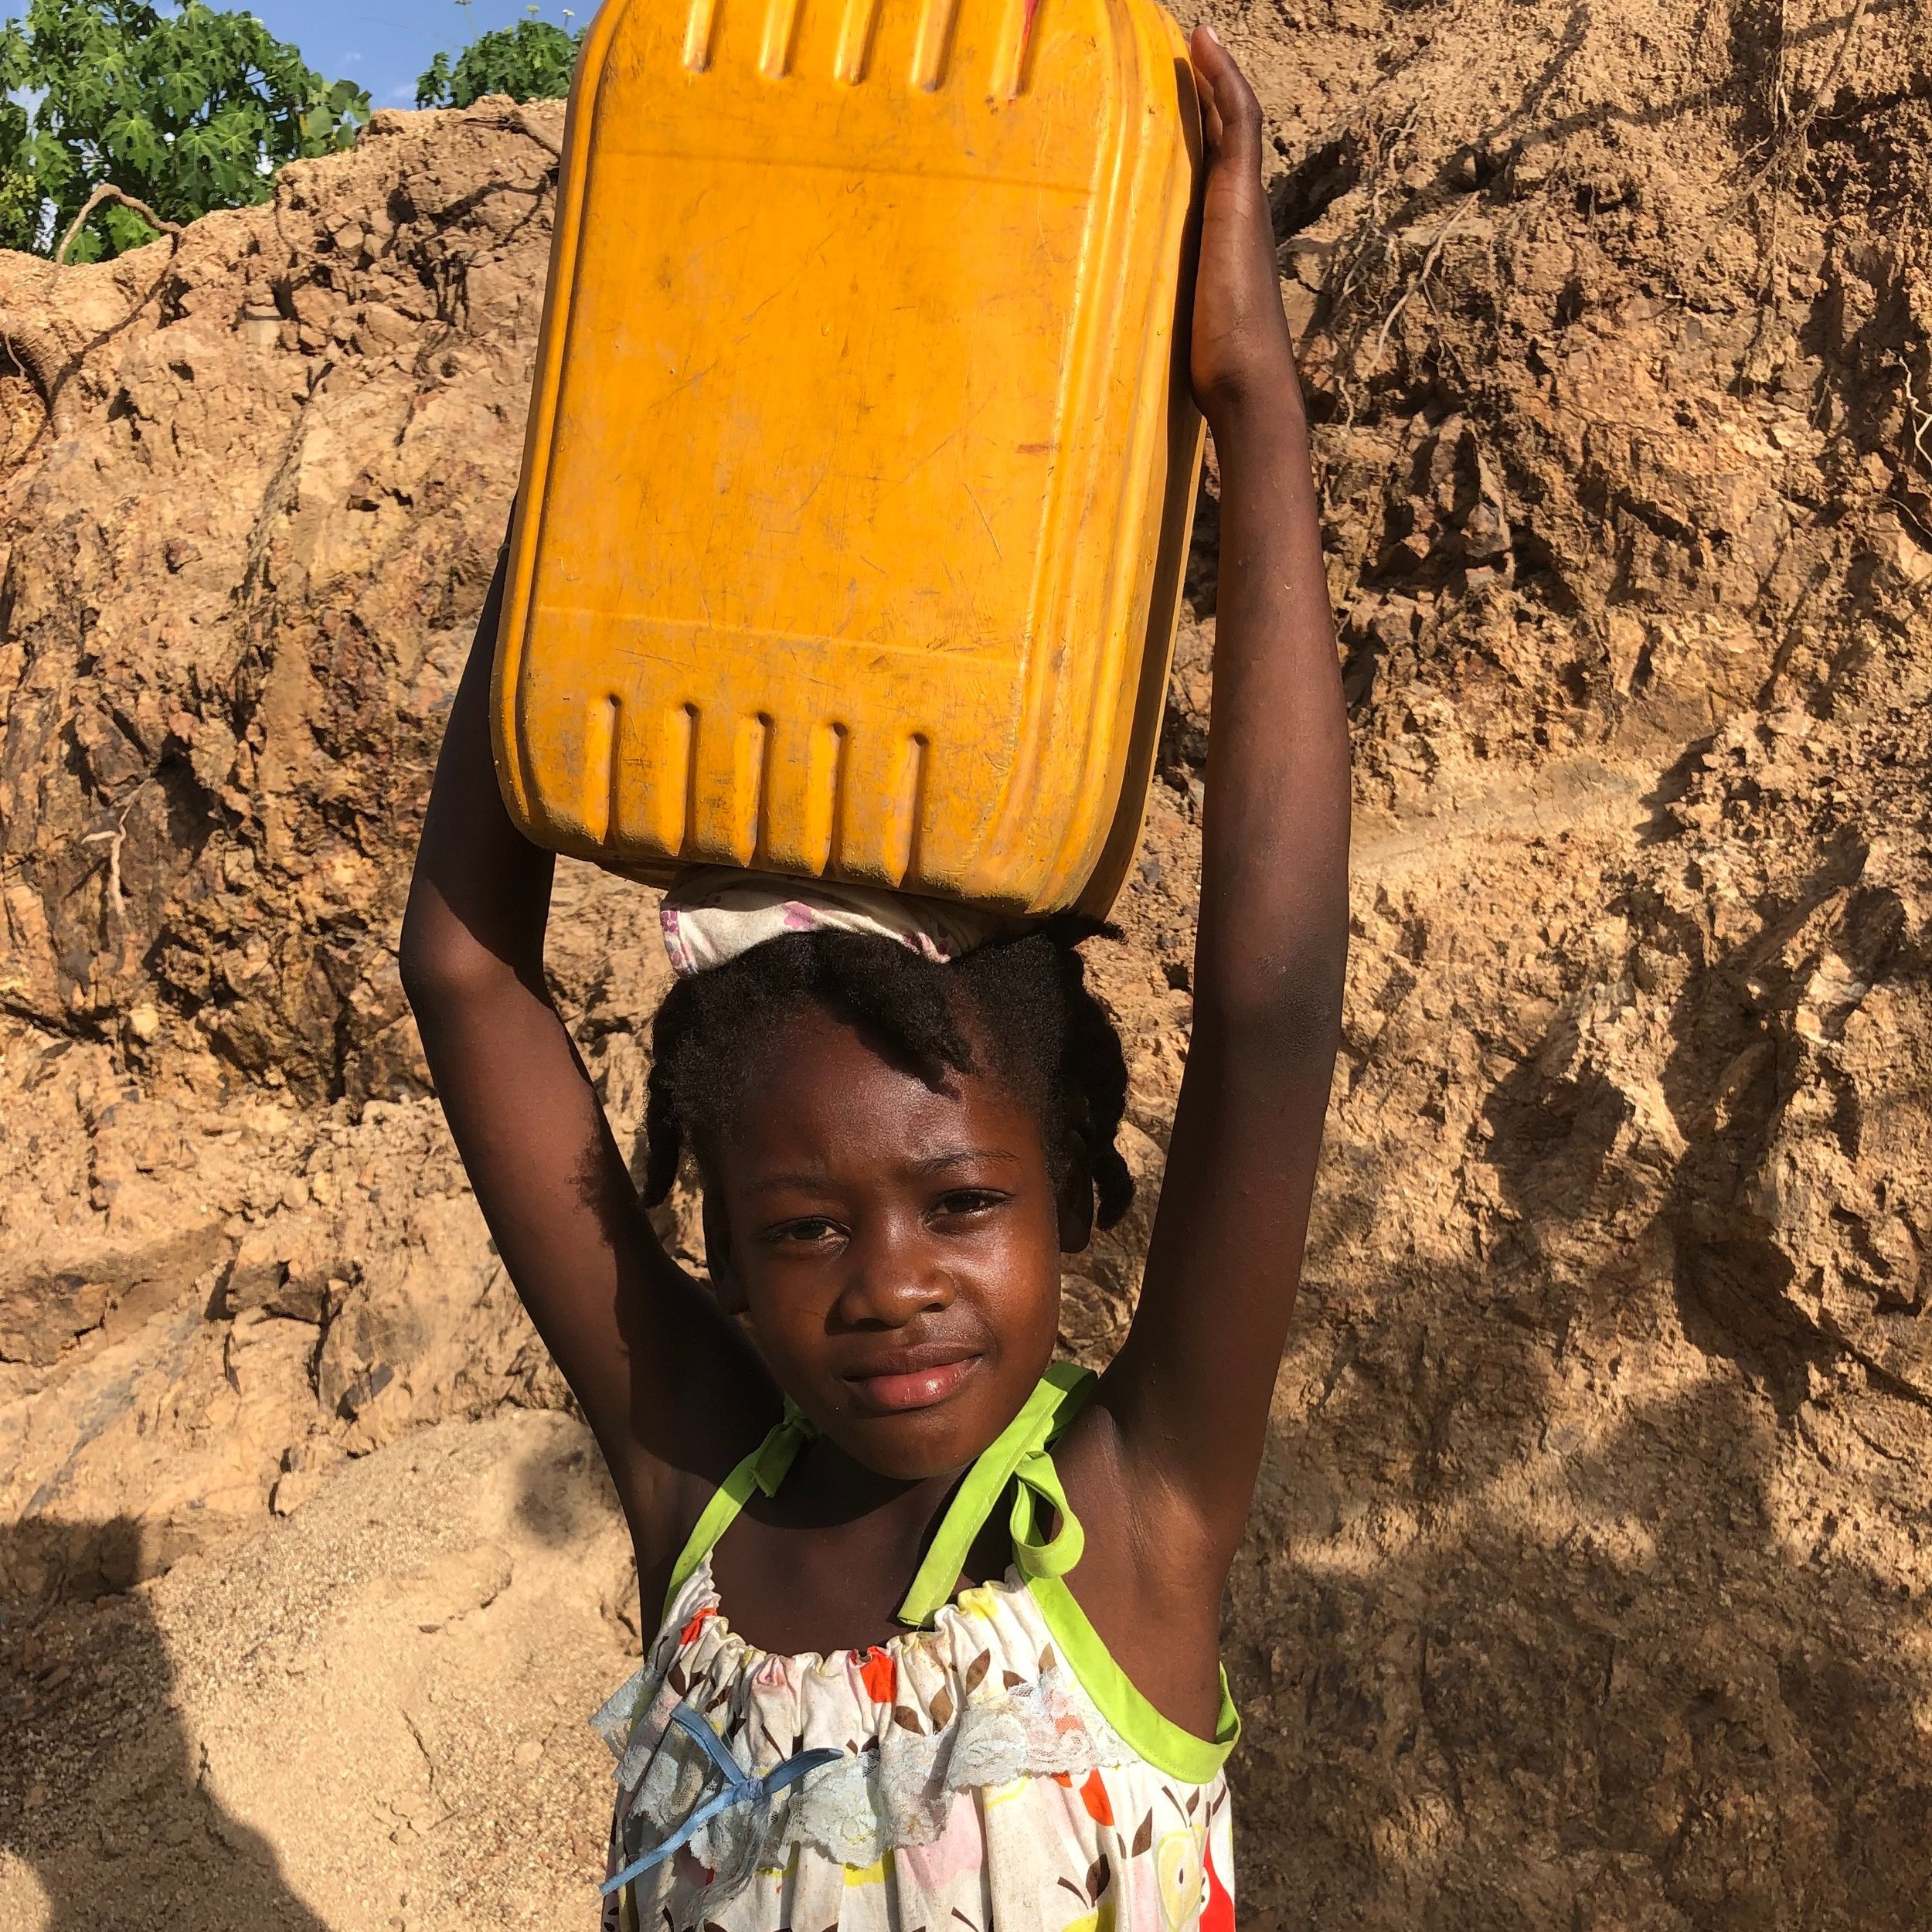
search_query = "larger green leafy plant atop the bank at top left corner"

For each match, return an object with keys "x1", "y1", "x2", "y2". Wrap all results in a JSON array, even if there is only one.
[{"x1": 0, "y1": 0, "x2": 369, "y2": 261}]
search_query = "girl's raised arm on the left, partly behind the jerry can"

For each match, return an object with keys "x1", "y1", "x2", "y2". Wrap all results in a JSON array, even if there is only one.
[{"x1": 402, "y1": 541, "x2": 777, "y2": 1561}]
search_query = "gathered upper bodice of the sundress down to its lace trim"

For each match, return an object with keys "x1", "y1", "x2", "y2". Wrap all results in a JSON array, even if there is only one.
[{"x1": 594, "y1": 1565, "x2": 1138, "y2": 1896}]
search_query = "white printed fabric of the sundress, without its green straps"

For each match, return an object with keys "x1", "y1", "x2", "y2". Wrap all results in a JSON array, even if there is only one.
[{"x1": 605, "y1": 1569, "x2": 1233, "y2": 1932}]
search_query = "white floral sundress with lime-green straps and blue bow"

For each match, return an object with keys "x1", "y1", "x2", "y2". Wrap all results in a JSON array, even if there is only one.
[{"x1": 594, "y1": 1364, "x2": 1240, "y2": 1932}]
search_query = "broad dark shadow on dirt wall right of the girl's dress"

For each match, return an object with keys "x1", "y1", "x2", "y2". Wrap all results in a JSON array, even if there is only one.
[{"x1": 1231, "y1": 1360, "x2": 1932, "y2": 1932}]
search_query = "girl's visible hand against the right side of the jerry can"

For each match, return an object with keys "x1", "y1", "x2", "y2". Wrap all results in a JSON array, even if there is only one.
[{"x1": 1189, "y1": 22, "x2": 1301, "y2": 439}]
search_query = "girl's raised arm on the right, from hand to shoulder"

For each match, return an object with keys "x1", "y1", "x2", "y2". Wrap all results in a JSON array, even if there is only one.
[{"x1": 1101, "y1": 29, "x2": 1349, "y2": 1598}]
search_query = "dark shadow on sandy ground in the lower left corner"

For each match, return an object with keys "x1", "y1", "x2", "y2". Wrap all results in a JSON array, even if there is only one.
[{"x1": 0, "y1": 1521, "x2": 328, "y2": 1932}]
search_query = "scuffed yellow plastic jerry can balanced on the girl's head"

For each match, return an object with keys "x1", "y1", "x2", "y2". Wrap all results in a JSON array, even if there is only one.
[{"x1": 495, "y1": 0, "x2": 1202, "y2": 912}]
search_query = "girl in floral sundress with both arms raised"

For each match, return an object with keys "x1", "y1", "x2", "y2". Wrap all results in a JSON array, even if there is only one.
[{"x1": 402, "y1": 27, "x2": 1349, "y2": 1932}]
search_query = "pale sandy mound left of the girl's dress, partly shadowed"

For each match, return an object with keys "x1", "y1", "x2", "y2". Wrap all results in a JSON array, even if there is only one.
[{"x1": 0, "y1": 1410, "x2": 636, "y2": 1932}]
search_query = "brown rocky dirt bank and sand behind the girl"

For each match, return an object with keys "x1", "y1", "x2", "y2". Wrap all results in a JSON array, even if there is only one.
[{"x1": 0, "y1": 0, "x2": 1932, "y2": 1932}]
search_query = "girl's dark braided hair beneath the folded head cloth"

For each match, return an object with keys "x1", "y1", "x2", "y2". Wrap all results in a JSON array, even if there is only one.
[{"x1": 644, "y1": 914, "x2": 1134, "y2": 1227}]
